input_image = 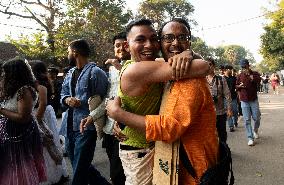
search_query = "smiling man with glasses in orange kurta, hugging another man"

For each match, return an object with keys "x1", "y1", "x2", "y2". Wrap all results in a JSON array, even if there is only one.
[{"x1": 107, "y1": 19, "x2": 219, "y2": 185}]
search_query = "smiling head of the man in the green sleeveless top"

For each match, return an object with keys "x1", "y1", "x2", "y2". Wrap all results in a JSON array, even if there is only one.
[{"x1": 126, "y1": 25, "x2": 160, "y2": 62}]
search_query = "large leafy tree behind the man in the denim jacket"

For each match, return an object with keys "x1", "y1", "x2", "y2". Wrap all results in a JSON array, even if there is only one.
[{"x1": 2, "y1": 0, "x2": 132, "y2": 67}]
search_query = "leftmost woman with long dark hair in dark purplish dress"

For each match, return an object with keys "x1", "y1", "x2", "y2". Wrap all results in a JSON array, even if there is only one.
[{"x1": 0, "y1": 59, "x2": 46, "y2": 185}]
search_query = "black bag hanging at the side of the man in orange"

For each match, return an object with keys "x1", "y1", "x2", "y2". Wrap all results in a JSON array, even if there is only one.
[{"x1": 180, "y1": 141, "x2": 235, "y2": 185}]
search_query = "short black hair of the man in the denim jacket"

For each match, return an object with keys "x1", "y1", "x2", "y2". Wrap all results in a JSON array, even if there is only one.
[{"x1": 69, "y1": 39, "x2": 91, "y2": 57}]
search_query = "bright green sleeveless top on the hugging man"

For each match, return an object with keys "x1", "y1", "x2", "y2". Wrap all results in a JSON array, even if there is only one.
[{"x1": 118, "y1": 60, "x2": 163, "y2": 148}]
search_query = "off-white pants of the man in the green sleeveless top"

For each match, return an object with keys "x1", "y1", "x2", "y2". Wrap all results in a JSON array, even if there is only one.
[{"x1": 119, "y1": 145, "x2": 154, "y2": 185}]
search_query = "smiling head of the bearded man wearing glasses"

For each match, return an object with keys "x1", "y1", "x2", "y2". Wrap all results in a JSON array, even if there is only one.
[{"x1": 161, "y1": 22, "x2": 190, "y2": 60}]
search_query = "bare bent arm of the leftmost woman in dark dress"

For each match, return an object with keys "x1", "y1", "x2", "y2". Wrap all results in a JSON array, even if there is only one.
[{"x1": 0, "y1": 89, "x2": 33, "y2": 123}]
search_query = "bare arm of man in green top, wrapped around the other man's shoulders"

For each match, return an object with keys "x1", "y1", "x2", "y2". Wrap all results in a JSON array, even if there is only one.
[{"x1": 121, "y1": 59, "x2": 209, "y2": 96}]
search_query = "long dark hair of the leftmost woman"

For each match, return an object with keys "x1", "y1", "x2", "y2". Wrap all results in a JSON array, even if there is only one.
[{"x1": 2, "y1": 59, "x2": 35, "y2": 98}]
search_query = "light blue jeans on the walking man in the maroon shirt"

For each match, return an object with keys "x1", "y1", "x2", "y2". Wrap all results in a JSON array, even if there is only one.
[{"x1": 241, "y1": 99, "x2": 260, "y2": 139}]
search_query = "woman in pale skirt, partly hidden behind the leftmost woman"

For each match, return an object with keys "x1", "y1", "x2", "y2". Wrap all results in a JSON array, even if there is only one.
[{"x1": 29, "y1": 60, "x2": 67, "y2": 185}]
